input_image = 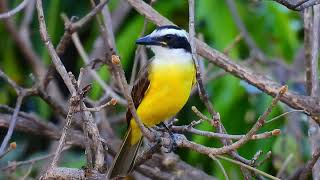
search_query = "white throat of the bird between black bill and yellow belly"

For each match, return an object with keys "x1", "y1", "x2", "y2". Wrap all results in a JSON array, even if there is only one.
[{"x1": 150, "y1": 46, "x2": 192, "y2": 64}]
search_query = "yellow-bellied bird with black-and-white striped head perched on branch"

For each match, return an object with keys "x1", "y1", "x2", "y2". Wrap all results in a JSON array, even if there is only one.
[{"x1": 108, "y1": 25, "x2": 195, "y2": 179}]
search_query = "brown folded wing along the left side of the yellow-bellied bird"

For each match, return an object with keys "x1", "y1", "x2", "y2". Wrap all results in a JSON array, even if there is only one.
[{"x1": 126, "y1": 61, "x2": 151, "y2": 126}]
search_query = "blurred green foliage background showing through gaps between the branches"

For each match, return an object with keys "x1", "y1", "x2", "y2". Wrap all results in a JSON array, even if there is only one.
[{"x1": 0, "y1": 0, "x2": 309, "y2": 179}]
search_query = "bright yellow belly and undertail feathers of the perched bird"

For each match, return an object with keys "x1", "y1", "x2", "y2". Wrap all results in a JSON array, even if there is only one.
[{"x1": 130, "y1": 63, "x2": 195, "y2": 144}]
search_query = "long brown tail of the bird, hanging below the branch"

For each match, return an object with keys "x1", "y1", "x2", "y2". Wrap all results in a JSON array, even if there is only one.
[{"x1": 108, "y1": 127, "x2": 142, "y2": 179}]
